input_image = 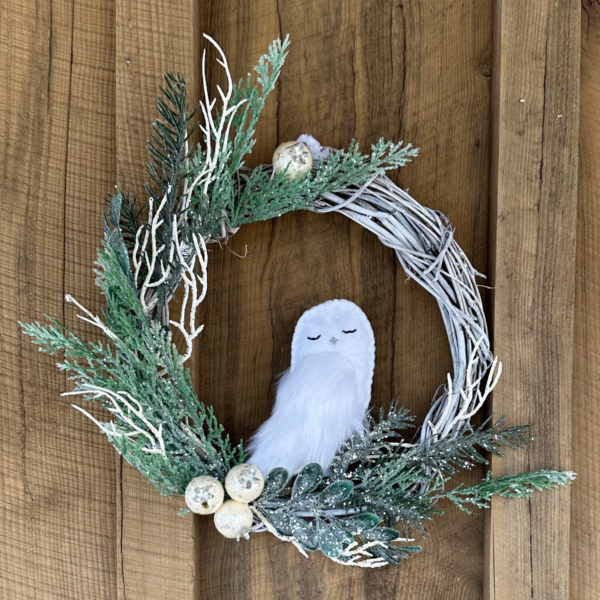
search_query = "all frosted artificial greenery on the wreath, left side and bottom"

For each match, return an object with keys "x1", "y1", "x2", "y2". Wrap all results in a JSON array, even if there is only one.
[{"x1": 23, "y1": 38, "x2": 573, "y2": 566}]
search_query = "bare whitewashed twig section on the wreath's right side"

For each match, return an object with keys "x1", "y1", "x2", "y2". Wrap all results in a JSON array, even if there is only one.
[{"x1": 311, "y1": 175, "x2": 502, "y2": 446}]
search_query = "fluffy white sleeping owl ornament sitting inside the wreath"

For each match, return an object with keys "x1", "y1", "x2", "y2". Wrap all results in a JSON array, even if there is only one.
[{"x1": 248, "y1": 300, "x2": 375, "y2": 475}]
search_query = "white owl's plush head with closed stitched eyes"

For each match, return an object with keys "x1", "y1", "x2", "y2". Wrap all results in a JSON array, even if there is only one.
[{"x1": 290, "y1": 300, "x2": 375, "y2": 402}]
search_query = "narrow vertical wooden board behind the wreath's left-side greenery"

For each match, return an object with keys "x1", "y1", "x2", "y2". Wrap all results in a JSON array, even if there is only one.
[{"x1": 116, "y1": 0, "x2": 198, "y2": 600}]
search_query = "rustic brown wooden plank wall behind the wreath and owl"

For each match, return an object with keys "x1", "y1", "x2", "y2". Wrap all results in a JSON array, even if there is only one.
[{"x1": 0, "y1": 0, "x2": 600, "y2": 600}]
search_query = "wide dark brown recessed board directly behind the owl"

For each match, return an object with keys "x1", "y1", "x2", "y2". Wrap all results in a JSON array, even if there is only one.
[{"x1": 196, "y1": 1, "x2": 492, "y2": 599}]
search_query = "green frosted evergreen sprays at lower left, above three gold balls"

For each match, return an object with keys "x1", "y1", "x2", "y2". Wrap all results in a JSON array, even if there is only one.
[{"x1": 24, "y1": 241, "x2": 244, "y2": 494}]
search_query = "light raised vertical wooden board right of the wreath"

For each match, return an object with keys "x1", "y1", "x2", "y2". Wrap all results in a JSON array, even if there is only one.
[{"x1": 485, "y1": 0, "x2": 580, "y2": 600}]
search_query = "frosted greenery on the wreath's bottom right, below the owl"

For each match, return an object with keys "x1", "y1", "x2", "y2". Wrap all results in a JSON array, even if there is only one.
[{"x1": 255, "y1": 402, "x2": 574, "y2": 564}]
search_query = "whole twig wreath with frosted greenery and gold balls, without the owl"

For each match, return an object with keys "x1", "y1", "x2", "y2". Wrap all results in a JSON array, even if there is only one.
[{"x1": 22, "y1": 35, "x2": 574, "y2": 567}]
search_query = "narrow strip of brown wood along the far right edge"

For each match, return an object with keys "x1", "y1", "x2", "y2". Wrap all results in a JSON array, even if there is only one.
[{"x1": 570, "y1": 0, "x2": 600, "y2": 600}]
